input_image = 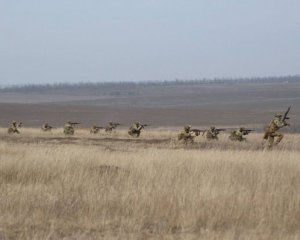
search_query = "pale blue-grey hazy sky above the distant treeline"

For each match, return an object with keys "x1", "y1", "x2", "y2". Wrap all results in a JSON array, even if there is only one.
[{"x1": 0, "y1": 0, "x2": 300, "y2": 85}]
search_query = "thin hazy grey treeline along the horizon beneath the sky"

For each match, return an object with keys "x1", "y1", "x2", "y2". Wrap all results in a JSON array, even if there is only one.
[{"x1": 0, "y1": 75, "x2": 300, "y2": 92}]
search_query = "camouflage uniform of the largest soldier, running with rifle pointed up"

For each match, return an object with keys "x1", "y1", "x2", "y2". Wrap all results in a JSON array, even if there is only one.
[{"x1": 263, "y1": 114, "x2": 289, "y2": 148}]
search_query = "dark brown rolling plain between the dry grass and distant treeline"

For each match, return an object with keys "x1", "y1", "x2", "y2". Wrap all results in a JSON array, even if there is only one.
[{"x1": 0, "y1": 81, "x2": 300, "y2": 130}]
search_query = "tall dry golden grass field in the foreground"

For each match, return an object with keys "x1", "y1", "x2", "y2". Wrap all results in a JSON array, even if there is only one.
[{"x1": 0, "y1": 126, "x2": 300, "y2": 240}]
